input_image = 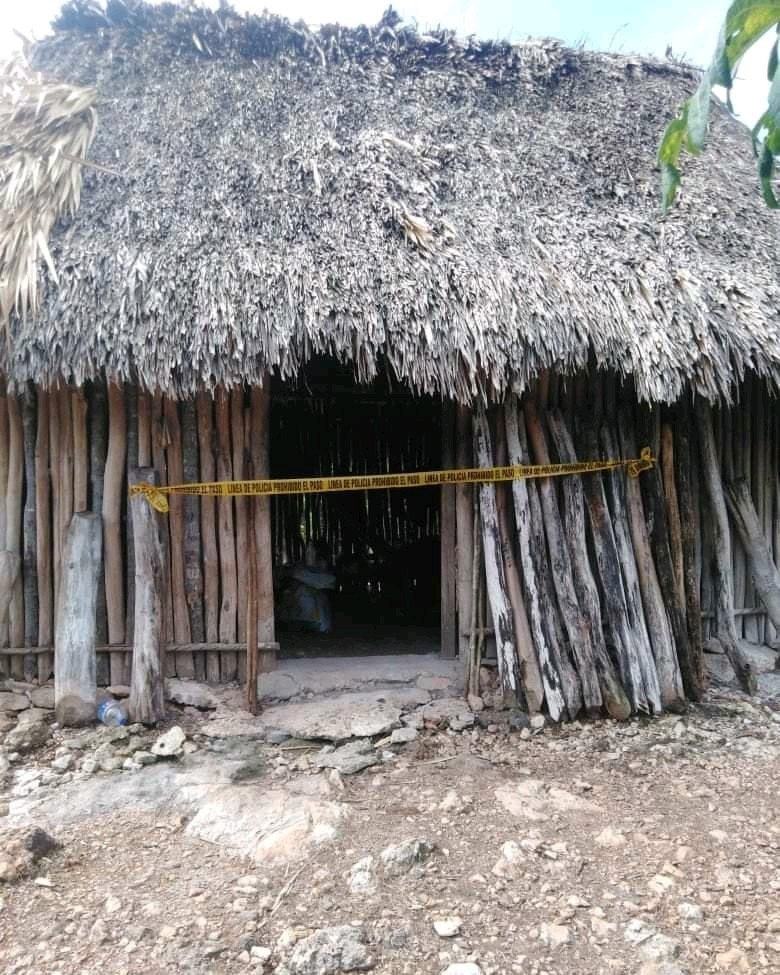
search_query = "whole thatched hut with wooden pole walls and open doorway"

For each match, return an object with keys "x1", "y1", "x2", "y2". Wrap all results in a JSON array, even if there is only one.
[{"x1": 0, "y1": 0, "x2": 780, "y2": 719}]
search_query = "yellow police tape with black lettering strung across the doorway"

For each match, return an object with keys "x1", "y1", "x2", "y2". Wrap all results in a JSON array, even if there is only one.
[{"x1": 130, "y1": 447, "x2": 655, "y2": 513}]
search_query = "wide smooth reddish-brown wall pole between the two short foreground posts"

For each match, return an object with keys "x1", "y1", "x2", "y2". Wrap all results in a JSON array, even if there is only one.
[{"x1": 103, "y1": 383, "x2": 127, "y2": 652}]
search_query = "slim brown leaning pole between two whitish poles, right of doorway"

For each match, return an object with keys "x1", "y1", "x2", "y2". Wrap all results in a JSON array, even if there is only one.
[{"x1": 495, "y1": 410, "x2": 544, "y2": 714}]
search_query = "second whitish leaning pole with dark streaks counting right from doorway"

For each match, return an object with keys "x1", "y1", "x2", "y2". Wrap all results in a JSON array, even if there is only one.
[{"x1": 504, "y1": 396, "x2": 566, "y2": 721}]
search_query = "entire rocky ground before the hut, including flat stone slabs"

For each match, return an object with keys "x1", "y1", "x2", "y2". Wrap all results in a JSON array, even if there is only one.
[{"x1": 0, "y1": 648, "x2": 780, "y2": 975}]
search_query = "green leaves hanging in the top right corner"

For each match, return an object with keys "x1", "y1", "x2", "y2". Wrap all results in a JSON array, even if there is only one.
[{"x1": 658, "y1": 0, "x2": 780, "y2": 212}]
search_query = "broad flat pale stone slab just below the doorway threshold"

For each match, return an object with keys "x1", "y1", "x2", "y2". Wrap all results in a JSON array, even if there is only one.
[{"x1": 263, "y1": 687, "x2": 430, "y2": 742}]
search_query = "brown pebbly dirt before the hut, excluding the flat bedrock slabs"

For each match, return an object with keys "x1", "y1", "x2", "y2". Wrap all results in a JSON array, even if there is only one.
[{"x1": 0, "y1": 691, "x2": 780, "y2": 975}]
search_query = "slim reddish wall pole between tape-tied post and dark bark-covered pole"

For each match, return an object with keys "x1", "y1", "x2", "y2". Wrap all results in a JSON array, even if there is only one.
[{"x1": 163, "y1": 396, "x2": 195, "y2": 678}]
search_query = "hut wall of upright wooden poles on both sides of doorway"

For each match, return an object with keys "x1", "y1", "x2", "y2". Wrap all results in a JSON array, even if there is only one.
[{"x1": 0, "y1": 376, "x2": 780, "y2": 700}]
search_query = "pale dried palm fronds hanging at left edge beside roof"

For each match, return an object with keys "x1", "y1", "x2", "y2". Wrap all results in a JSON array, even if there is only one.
[{"x1": 0, "y1": 54, "x2": 97, "y2": 328}]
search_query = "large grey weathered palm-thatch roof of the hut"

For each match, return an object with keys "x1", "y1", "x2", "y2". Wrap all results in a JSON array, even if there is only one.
[{"x1": 1, "y1": 0, "x2": 780, "y2": 400}]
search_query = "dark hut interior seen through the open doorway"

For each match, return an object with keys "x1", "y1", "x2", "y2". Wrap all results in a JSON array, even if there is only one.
[{"x1": 271, "y1": 361, "x2": 441, "y2": 656}]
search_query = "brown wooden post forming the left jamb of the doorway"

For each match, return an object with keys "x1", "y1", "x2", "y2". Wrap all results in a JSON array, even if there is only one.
[{"x1": 250, "y1": 386, "x2": 276, "y2": 673}]
